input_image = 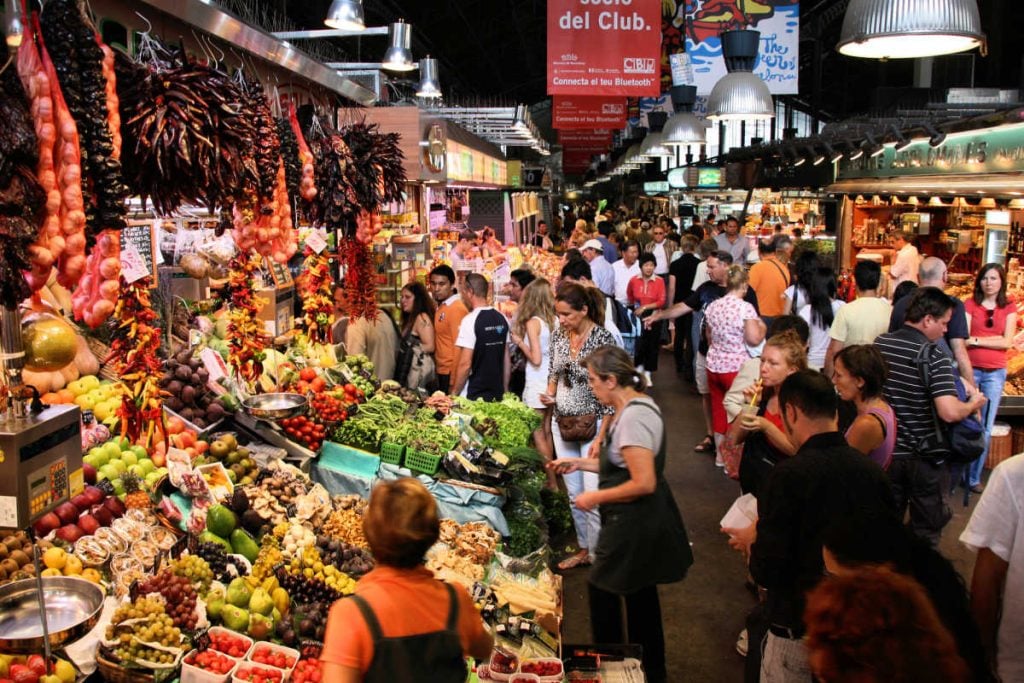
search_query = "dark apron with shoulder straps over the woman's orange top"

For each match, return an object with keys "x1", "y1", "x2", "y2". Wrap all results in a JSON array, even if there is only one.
[{"x1": 351, "y1": 584, "x2": 467, "y2": 683}]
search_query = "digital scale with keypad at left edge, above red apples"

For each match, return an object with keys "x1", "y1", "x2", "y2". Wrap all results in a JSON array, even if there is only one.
[{"x1": 0, "y1": 405, "x2": 85, "y2": 528}]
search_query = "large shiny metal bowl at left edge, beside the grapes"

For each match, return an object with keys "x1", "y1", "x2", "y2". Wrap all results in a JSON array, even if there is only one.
[{"x1": 0, "y1": 577, "x2": 103, "y2": 652}]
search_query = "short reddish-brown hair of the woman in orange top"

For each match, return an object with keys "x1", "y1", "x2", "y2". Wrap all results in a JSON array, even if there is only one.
[{"x1": 362, "y1": 477, "x2": 440, "y2": 569}]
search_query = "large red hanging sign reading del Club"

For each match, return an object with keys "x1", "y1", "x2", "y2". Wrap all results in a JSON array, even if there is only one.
[{"x1": 548, "y1": 0, "x2": 662, "y2": 97}]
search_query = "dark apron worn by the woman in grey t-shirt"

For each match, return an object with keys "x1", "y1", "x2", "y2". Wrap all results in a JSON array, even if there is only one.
[{"x1": 590, "y1": 402, "x2": 693, "y2": 595}]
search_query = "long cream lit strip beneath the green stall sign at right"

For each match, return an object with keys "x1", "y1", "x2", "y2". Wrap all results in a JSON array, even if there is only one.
[{"x1": 825, "y1": 173, "x2": 1024, "y2": 197}]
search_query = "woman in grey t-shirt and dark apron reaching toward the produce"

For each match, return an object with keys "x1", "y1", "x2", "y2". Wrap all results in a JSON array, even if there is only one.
[{"x1": 549, "y1": 346, "x2": 693, "y2": 683}]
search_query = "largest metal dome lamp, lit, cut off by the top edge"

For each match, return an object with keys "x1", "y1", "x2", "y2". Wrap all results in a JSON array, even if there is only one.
[{"x1": 838, "y1": 0, "x2": 985, "y2": 59}]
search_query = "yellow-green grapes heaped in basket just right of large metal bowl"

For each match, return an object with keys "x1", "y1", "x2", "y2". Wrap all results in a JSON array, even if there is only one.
[{"x1": 106, "y1": 597, "x2": 181, "y2": 664}]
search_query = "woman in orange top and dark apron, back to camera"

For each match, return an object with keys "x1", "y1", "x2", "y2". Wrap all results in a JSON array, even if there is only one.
[{"x1": 321, "y1": 478, "x2": 493, "y2": 683}]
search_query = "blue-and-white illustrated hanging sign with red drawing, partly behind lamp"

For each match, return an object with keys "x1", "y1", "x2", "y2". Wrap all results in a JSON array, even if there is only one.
[{"x1": 654, "y1": 0, "x2": 800, "y2": 95}]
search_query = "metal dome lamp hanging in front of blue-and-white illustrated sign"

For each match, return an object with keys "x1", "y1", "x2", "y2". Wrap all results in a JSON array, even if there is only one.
[{"x1": 708, "y1": 31, "x2": 775, "y2": 121}]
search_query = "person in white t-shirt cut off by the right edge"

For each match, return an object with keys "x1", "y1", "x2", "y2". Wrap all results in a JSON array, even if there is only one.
[{"x1": 961, "y1": 456, "x2": 1024, "y2": 681}]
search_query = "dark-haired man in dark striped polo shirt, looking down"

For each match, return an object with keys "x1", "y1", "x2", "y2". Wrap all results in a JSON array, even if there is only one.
[{"x1": 874, "y1": 287, "x2": 985, "y2": 545}]
